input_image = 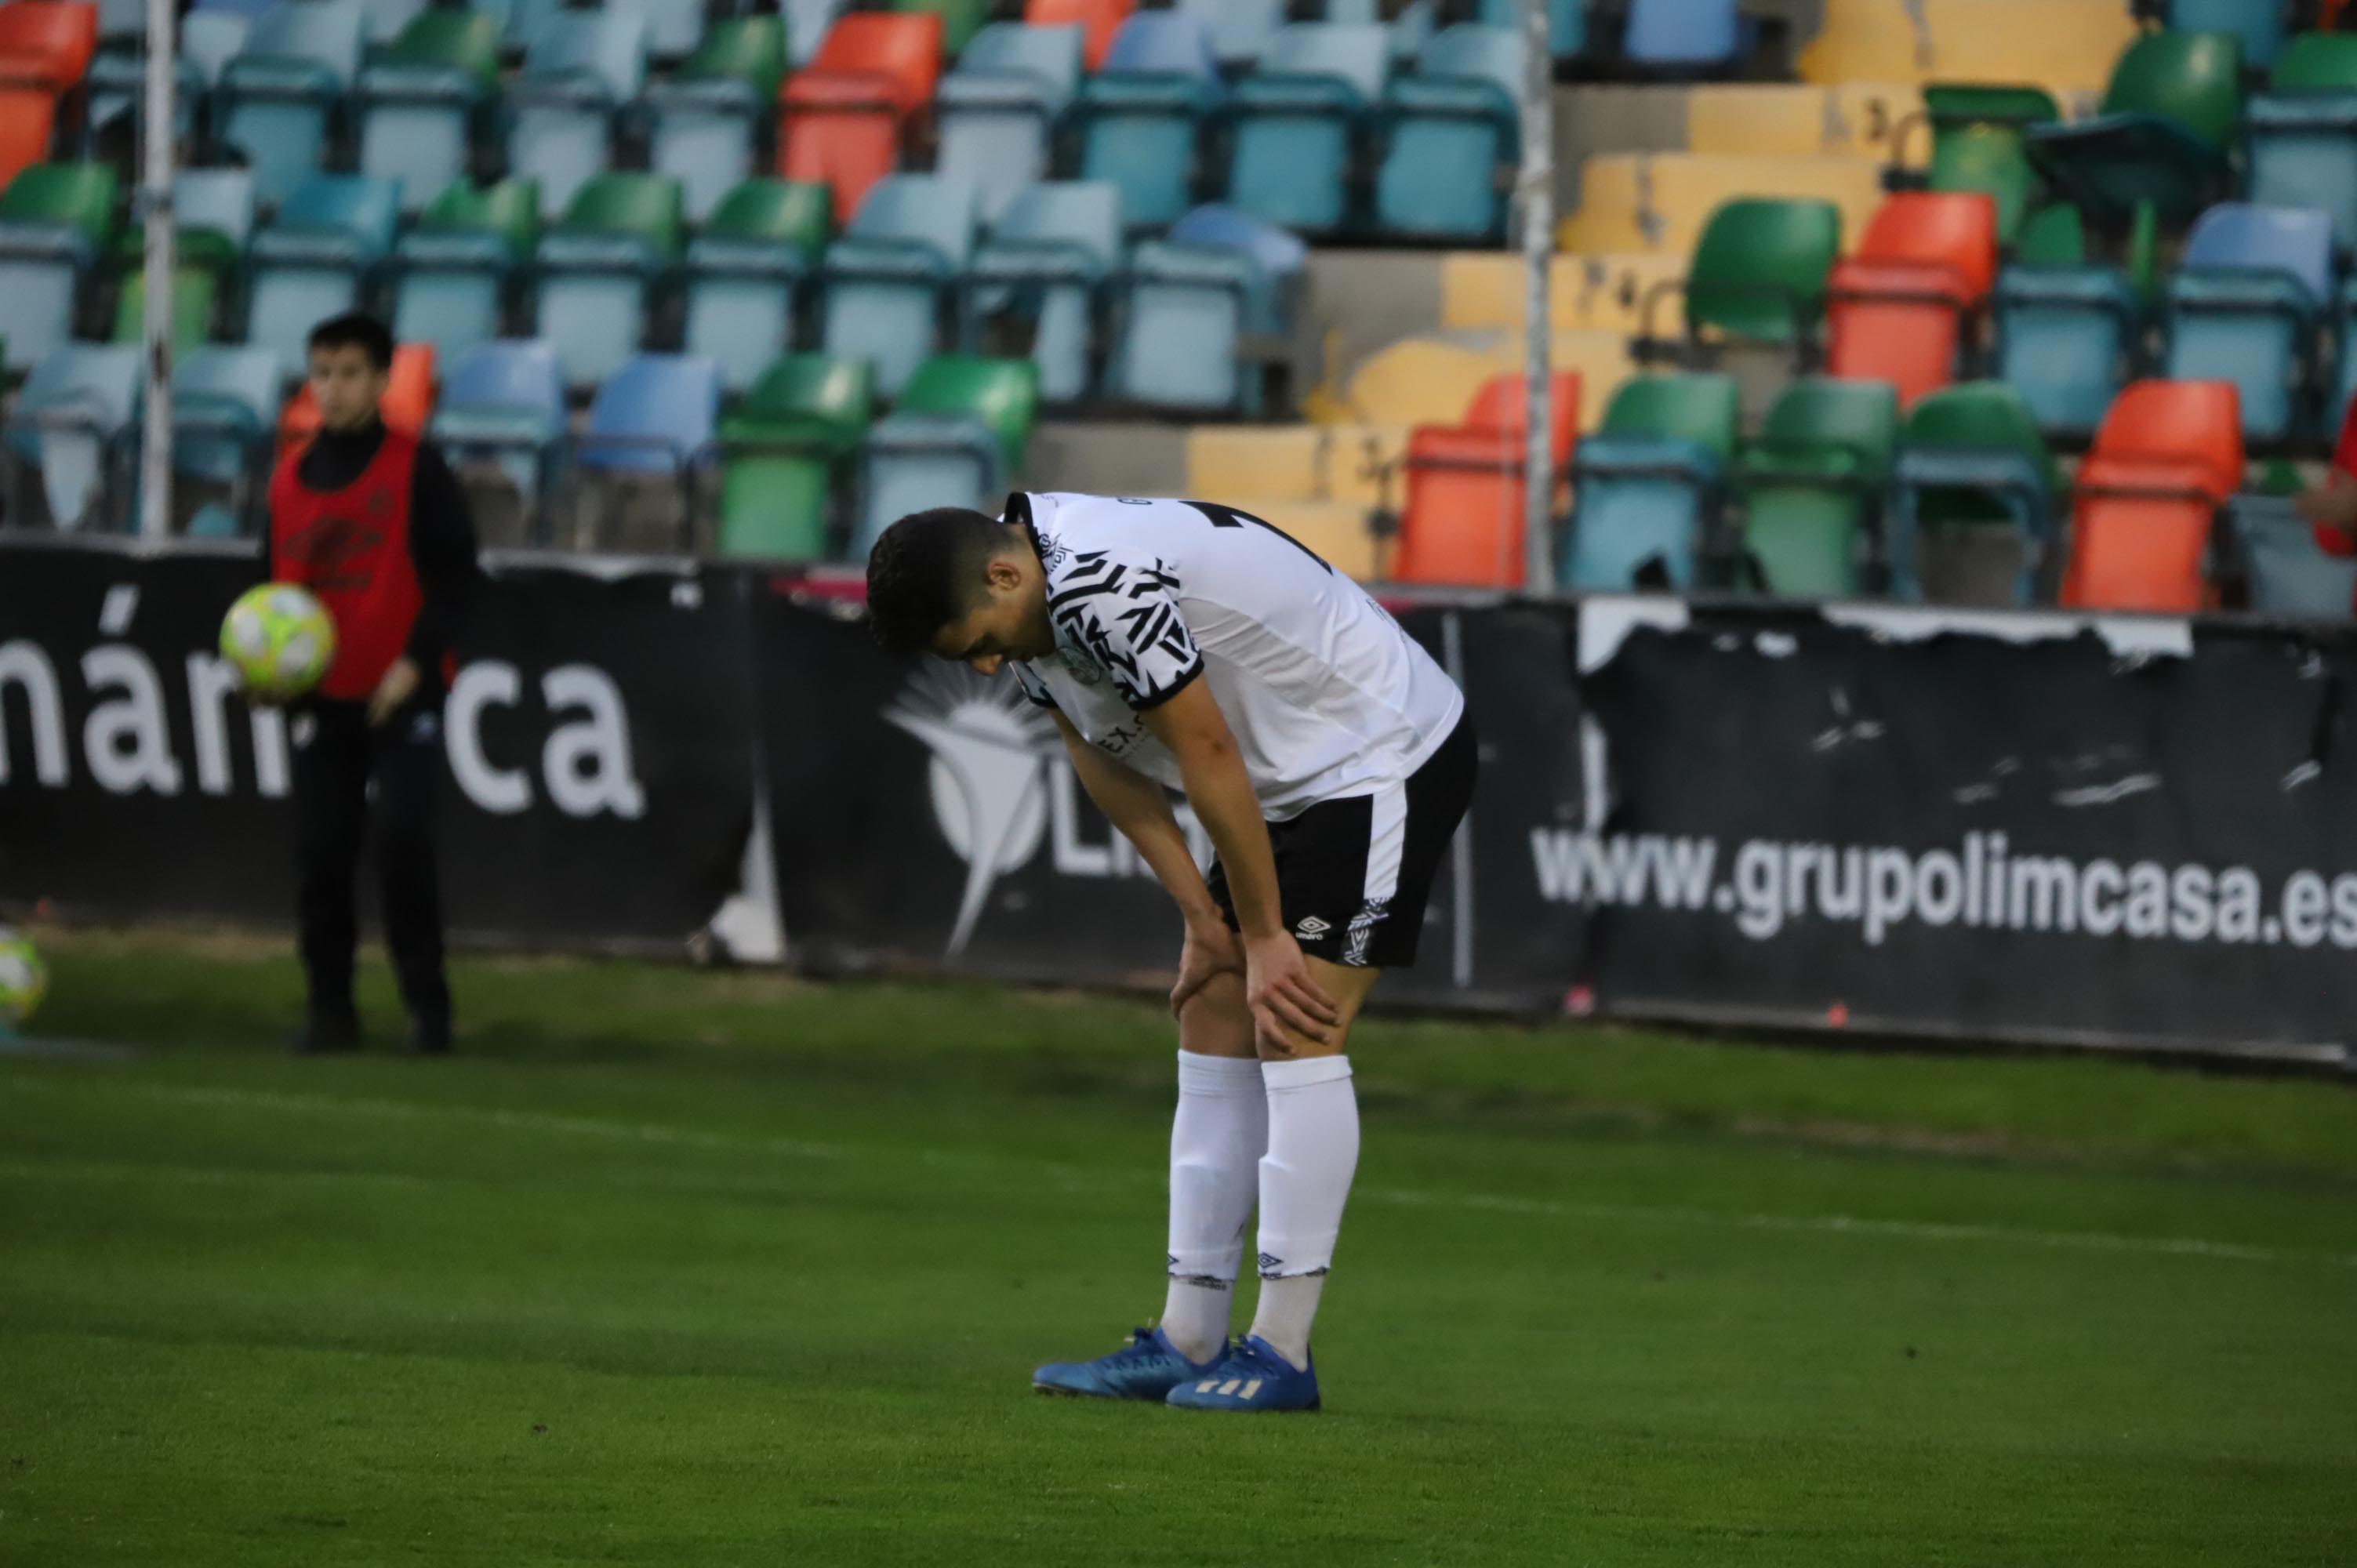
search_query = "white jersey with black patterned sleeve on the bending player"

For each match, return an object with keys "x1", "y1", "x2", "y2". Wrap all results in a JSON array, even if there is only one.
[{"x1": 1007, "y1": 493, "x2": 1464, "y2": 823}]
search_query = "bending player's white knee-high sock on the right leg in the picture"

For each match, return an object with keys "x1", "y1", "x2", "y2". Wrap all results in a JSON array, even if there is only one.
[{"x1": 1251, "y1": 1056, "x2": 1357, "y2": 1367}]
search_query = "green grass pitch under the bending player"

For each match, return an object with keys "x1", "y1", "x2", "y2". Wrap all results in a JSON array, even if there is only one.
[{"x1": 0, "y1": 931, "x2": 2357, "y2": 1568}]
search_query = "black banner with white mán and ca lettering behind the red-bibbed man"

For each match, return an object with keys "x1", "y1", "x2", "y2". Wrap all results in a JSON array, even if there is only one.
[{"x1": 0, "y1": 543, "x2": 752, "y2": 948}]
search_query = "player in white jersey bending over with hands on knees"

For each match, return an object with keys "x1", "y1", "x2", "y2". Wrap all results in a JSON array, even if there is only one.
[{"x1": 867, "y1": 495, "x2": 1476, "y2": 1410}]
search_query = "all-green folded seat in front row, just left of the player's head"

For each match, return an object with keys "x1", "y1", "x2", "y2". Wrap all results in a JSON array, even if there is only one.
[{"x1": 714, "y1": 354, "x2": 874, "y2": 561}]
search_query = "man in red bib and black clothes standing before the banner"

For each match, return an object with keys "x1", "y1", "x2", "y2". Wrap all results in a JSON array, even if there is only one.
[{"x1": 264, "y1": 314, "x2": 476, "y2": 1054}]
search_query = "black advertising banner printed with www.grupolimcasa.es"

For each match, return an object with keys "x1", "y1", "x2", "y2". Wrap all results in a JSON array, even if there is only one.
[{"x1": 1564, "y1": 601, "x2": 2357, "y2": 1051}]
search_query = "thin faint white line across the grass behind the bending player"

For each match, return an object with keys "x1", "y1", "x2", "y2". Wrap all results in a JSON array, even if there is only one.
[{"x1": 19, "y1": 1080, "x2": 2357, "y2": 1269}]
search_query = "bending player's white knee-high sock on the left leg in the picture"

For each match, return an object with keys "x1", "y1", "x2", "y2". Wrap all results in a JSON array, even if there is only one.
[{"x1": 1162, "y1": 1051, "x2": 1268, "y2": 1360}]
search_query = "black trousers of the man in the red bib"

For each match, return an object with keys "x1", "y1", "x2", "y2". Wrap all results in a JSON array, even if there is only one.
[{"x1": 295, "y1": 691, "x2": 450, "y2": 1030}]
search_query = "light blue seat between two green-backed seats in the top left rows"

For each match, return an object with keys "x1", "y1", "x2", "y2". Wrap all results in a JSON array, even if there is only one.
[{"x1": 507, "y1": 12, "x2": 646, "y2": 220}]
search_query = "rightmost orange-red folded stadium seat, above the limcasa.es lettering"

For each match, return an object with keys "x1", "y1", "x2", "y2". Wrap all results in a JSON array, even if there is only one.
[{"x1": 2060, "y1": 382, "x2": 2244, "y2": 615}]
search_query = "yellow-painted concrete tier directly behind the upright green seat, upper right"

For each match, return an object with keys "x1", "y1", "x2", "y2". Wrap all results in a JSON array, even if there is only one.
[{"x1": 1556, "y1": 153, "x2": 1883, "y2": 257}]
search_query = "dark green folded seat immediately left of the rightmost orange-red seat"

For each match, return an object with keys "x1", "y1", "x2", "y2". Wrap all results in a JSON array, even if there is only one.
[{"x1": 1883, "y1": 382, "x2": 2057, "y2": 606}]
